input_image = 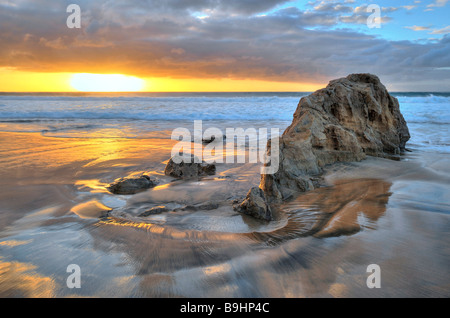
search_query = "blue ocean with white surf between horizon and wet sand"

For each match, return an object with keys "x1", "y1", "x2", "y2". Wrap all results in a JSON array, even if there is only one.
[{"x1": 0, "y1": 93, "x2": 450, "y2": 153}]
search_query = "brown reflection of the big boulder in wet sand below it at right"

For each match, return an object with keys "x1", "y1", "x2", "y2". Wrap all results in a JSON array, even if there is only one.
[{"x1": 282, "y1": 179, "x2": 392, "y2": 237}]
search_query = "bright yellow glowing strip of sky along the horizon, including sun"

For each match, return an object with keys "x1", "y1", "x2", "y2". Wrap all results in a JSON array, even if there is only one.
[{"x1": 0, "y1": 68, "x2": 326, "y2": 92}]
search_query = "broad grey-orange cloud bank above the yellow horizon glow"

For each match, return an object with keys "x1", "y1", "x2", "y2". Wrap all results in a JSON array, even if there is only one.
[{"x1": 0, "y1": 0, "x2": 450, "y2": 89}]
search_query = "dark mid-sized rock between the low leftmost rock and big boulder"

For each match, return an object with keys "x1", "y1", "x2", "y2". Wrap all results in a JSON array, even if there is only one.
[{"x1": 164, "y1": 155, "x2": 216, "y2": 179}]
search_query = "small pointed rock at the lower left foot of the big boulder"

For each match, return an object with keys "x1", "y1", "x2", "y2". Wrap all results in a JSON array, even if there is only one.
[{"x1": 237, "y1": 187, "x2": 273, "y2": 221}]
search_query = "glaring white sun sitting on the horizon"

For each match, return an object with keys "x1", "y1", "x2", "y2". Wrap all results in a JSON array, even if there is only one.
[{"x1": 70, "y1": 73, "x2": 145, "y2": 92}]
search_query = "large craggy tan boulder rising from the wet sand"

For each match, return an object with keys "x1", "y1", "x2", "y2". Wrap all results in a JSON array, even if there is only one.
[{"x1": 240, "y1": 74, "x2": 410, "y2": 220}]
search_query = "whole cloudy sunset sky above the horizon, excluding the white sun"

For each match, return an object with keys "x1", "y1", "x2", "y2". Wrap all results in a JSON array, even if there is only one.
[{"x1": 0, "y1": 0, "x2": 450, "y2": 92}]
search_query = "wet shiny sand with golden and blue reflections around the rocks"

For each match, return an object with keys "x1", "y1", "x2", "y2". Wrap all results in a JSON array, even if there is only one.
[{"x1": 0, "y1": 132, "x2": 450, "y2": 297}]
